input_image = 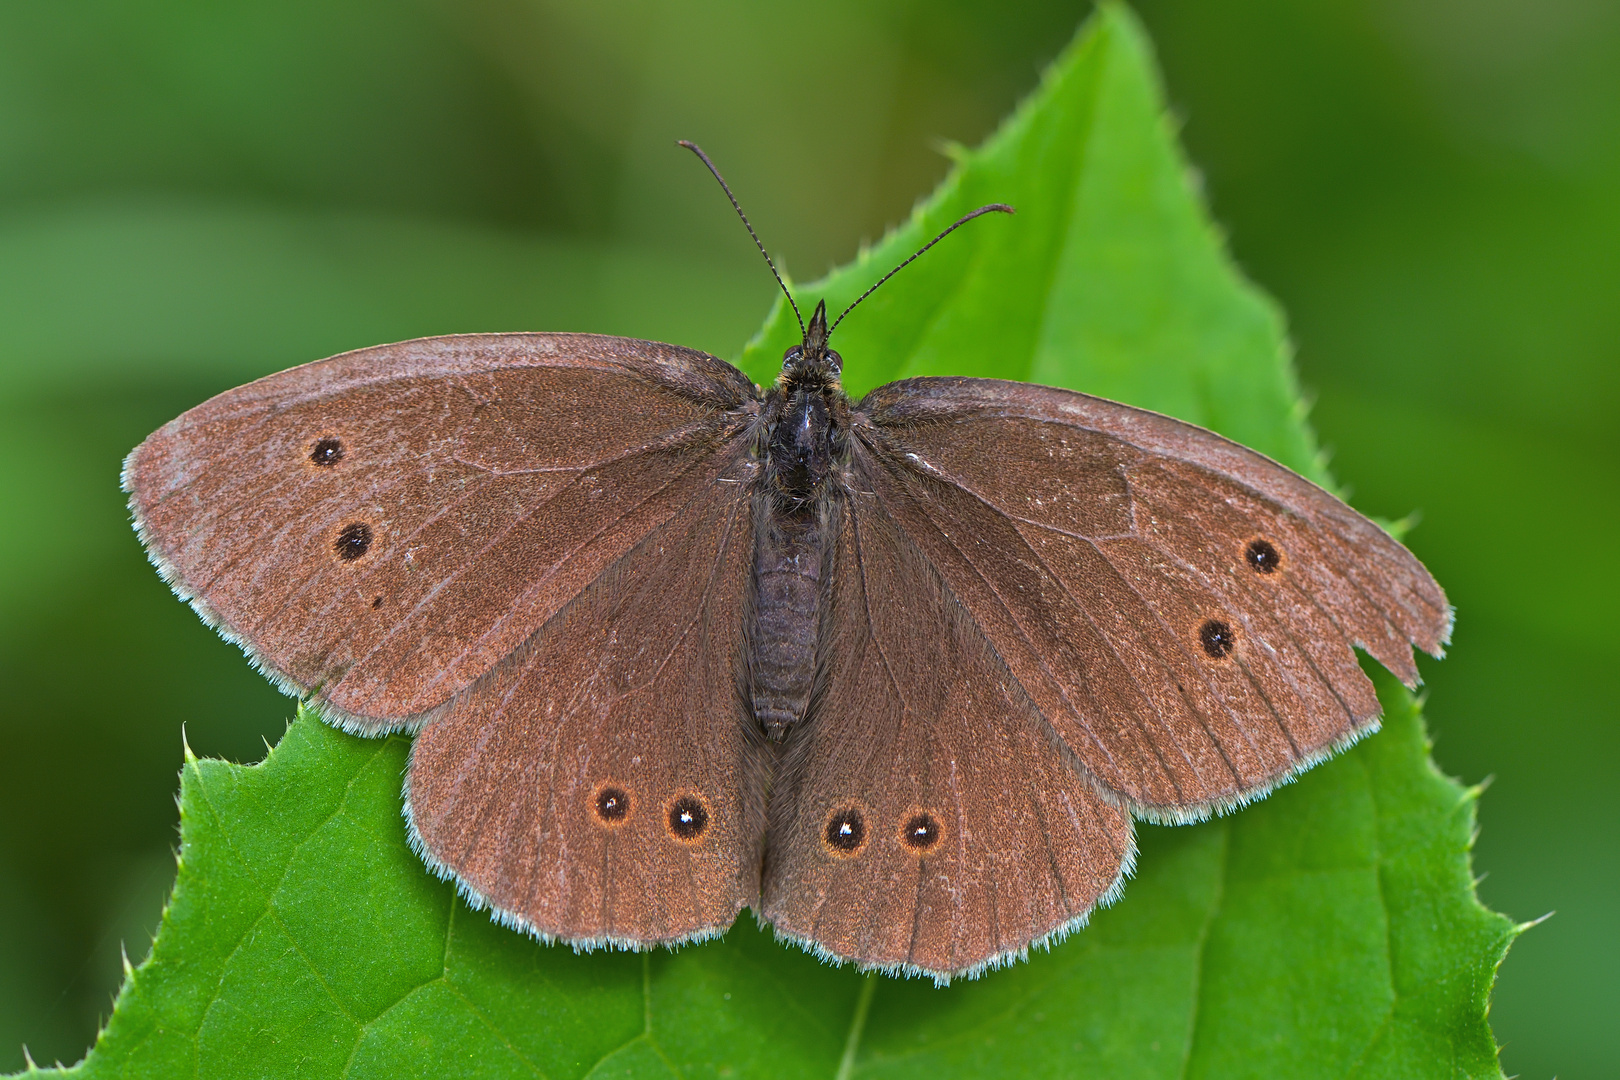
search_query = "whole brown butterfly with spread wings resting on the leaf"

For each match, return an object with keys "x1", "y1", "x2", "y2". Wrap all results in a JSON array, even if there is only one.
[{"x1": 125, "y1": 147, "x2": 1452, "y2": 981}]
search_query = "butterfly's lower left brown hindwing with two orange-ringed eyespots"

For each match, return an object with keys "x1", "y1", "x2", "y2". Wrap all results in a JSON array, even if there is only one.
[{"x1": 407, "y1": 459, "x2": 768, "y2": 947}]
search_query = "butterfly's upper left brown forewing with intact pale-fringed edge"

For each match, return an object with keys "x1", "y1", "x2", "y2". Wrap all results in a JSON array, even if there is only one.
[{"x1": 125, "y1": 334, "x2": 757, "y2": 732}]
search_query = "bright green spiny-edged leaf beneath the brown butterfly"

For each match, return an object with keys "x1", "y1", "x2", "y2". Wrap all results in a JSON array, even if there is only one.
[{"x1": 25, "y1": 8, "x2": 1516, "y2": 1077}]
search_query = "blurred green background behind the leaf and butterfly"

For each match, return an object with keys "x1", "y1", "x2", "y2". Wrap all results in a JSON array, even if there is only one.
[{"x1": 0, "y1": 0, "x2": 1620, "y2": 1080}]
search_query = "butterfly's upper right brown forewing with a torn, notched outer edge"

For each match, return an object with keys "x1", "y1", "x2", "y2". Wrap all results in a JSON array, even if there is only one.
[{"x1": 855, "y1": 379, "x2": 1452, "y2": 819}]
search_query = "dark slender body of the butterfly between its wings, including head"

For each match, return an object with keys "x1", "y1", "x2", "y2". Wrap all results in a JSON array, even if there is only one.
[{"x1": 748, "y1": 309, "x2": 849, "y2": 740}]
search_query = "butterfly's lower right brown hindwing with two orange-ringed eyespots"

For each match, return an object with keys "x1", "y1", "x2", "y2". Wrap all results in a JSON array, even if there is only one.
[{"x1": 761, "y1": 472, "x2": 1134, "y2": 980}]
